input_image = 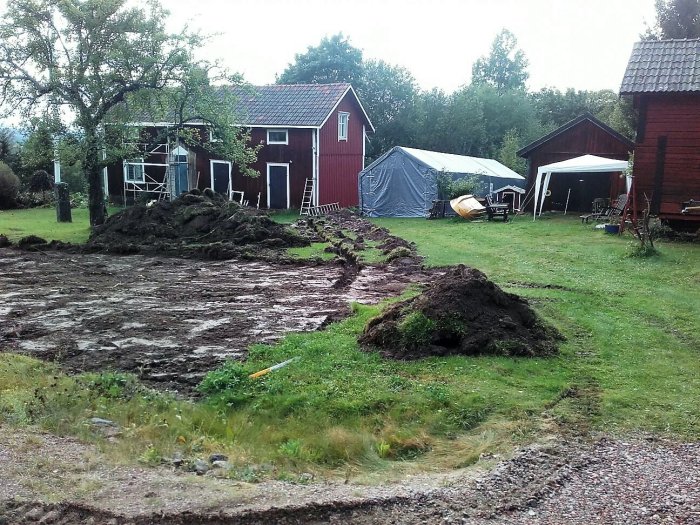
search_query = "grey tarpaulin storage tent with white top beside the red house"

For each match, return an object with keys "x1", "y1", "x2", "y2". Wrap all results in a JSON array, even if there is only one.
[{"x1": 358, "y1": 146, "x2": 525, "y2": 217}]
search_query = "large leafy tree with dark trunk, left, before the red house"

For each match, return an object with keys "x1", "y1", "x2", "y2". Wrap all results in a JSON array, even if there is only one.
[{"x1": 0, "y1": 0, "x2": 252, "y2": 225}]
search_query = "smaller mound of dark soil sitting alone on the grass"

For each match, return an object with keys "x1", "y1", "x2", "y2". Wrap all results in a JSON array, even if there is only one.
[{"x1": 360, "y1": 265, "x2": 563, "y2": 359}]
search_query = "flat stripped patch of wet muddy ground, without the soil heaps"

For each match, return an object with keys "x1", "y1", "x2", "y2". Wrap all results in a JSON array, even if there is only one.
[{"x1": 0, "y1": 249, "x2": 430, "y2": 390}]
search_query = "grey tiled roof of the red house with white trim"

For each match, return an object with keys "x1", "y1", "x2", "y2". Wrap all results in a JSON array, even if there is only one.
[{"x1": 232, "y1": 83, "x2": 369, "y2": 126}]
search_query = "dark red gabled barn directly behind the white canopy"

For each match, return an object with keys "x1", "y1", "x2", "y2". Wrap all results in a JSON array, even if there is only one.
[{"x1": 518, "y1": 113, "x2": 634, "y2": 212}]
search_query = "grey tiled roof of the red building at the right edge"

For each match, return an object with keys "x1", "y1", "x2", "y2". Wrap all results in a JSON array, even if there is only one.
[{"x1": 620, "y1": 39, "x2": 700, "y2": 95}]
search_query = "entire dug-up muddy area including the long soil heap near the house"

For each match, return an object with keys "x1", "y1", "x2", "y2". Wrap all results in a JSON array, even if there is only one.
[{"x1": 0, "y1": 208, "x2": 432, "y2": 393}]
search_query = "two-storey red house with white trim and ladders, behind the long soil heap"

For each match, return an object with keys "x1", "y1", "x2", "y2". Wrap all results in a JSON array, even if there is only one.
[{"x1": 108, "y1": 83, "x2": 374, "y2": 209}]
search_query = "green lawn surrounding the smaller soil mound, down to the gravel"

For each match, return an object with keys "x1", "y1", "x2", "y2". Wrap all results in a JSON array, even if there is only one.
[{"x1": 0, "y1": 210, "x2": 700, "y2": 481}]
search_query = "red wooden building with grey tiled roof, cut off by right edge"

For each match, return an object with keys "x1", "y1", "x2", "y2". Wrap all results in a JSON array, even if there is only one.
[{"x1": 620, "y1": 39, "x2": 700, "y2": 222}]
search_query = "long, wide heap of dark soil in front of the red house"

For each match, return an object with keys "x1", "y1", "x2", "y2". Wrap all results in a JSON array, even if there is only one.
[{"x1": 86, "y1": 190, "x2": 309, "y2": 259}]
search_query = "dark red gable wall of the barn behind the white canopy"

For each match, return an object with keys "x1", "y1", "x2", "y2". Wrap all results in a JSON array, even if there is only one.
[{"x1": 526, "y1": 120, "x2": 631, "y2": 211}]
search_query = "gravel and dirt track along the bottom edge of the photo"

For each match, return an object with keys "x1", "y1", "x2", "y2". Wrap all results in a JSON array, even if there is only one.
[{"x1": 0, "y1": 426, "x2": 700, "y2": 525}]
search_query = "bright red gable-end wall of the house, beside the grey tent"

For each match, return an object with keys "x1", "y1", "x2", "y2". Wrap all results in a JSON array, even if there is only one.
[{"x1": 318, "y1": 93, "x2": 365, "y2": 207}]
